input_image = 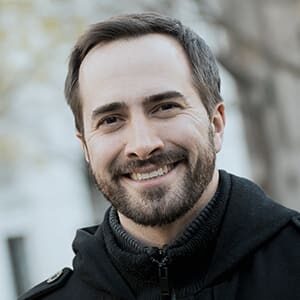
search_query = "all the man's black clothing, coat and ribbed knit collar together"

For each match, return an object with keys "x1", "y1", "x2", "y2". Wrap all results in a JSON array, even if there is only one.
[{"x1": 18, "y1": 171, "x2": 300, "y2": 300}]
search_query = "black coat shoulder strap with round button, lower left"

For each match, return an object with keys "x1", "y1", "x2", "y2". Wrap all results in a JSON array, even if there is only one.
[{"x1": 18, "y1": 268, "x2": 73, "y2": 300}]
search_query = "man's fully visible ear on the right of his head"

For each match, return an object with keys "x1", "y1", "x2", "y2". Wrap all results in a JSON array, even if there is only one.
[{"x1": 211, "y1": 102, "x2": 226, "y2": 153}]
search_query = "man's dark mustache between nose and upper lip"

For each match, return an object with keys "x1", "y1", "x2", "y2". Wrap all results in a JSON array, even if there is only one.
[{"x1": 109, "y1": 148, "x2": 188, "y2": 177}]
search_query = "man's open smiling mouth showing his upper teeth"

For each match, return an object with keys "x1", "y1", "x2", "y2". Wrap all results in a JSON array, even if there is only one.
[{"x1": 125, "y1": 162, "x2": 179, "y2": 181}]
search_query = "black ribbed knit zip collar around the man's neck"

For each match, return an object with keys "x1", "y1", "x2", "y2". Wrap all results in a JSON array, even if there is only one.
[{"x1": 102, "y1": 171, "x2": 230, "y2": 294}]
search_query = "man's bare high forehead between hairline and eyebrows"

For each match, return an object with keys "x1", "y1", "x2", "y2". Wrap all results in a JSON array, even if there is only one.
[{"x1": 79, "y1": 34, "x2": 191, "y2": 108}]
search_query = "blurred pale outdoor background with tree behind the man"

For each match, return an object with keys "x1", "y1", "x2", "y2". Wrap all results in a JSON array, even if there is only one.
[{"x1": 0, "y1": 0, "x2": 300, "y2": 300}]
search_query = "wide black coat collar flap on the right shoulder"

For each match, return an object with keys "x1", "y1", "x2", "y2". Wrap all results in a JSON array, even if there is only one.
[{"x1": 205, "y1": 171, "x2": 297, "y2": 286}]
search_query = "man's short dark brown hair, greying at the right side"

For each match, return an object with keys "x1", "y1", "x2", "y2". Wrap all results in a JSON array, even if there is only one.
[{"x1": 65, "y1": 13, "x2": 222, "y2": 135}]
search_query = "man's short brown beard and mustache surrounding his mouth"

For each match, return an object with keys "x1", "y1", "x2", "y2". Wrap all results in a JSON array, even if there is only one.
[{"x1": 90, "y1": 128, "x2": 216, "y2": 226}]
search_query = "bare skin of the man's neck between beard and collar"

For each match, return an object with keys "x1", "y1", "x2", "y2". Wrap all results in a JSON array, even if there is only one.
[{"x1": 118, "y1": 170, "x2": 219, "y2": 248}]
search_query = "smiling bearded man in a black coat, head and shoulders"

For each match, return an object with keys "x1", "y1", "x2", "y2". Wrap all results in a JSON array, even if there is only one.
[{"x1": 20, "y1": 13, "x2": 300, "y2": 300}]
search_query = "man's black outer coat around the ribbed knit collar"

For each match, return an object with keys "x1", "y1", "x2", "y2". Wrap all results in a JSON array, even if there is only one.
[{"x1": 19, "y1": 171, "x2": 300, "y2": 300}]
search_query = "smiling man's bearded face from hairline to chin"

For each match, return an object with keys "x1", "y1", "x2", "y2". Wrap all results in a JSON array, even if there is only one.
[{"x1": 79, "y1": 34, "x2": 224, "y2": 226}]
